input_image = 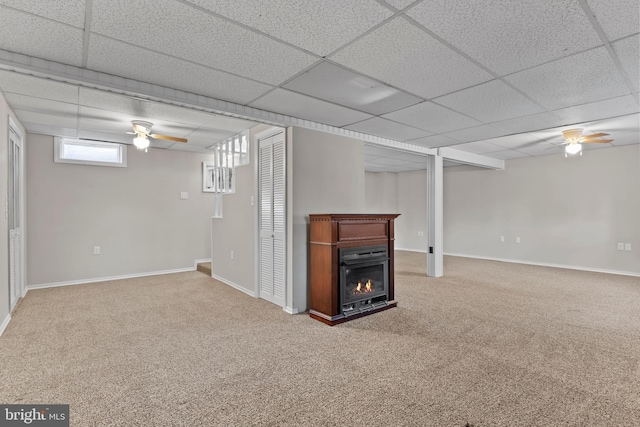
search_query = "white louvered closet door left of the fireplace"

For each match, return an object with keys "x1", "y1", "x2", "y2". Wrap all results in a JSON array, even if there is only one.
[{"x1": 258, "y1": 132, "x2": 286, "y2": 307}]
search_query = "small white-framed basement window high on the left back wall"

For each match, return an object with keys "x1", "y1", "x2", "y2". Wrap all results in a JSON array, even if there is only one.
[{"x1": 54, "y1": 137, "x2": 127, "y2": 167}]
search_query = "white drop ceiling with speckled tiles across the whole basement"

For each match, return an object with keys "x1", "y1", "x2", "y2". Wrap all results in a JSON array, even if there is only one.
[{"x1": 0, "y1": 0, "x2": 640, "y2": 171}]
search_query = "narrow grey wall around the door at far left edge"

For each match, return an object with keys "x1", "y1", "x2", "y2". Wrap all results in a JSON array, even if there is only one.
[{"x1": 0, "y1": 92, "x2": 27, "y2": 334}]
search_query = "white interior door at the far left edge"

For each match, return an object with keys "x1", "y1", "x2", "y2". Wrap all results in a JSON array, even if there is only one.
[{"x1": 7, "y1": 126, "x2": 24, "y2": 310}]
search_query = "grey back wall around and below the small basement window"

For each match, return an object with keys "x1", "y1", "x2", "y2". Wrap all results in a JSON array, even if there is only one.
[{"x1": 26, "y1": 134, "x2": 214, "y2": 285}]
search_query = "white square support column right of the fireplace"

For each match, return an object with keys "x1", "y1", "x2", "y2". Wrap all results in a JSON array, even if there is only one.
[{"x1": 427, "y1": 155, "x2": 444, "y2": 277}]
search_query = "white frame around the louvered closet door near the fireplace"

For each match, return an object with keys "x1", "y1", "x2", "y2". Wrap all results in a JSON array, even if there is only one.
[{"x1": 251, "y1": 126, "x2": 289, "y2": 311}]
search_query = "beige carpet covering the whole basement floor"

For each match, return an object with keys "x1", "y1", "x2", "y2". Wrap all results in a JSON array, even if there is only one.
[{"x1": 0, "y1": 252, "x2": 640, "y2": 427}]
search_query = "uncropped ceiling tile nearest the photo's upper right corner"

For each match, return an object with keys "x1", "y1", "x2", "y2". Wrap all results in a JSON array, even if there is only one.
[{"x1": 505, "y1": 47, "x2": 629, "y2": 110}]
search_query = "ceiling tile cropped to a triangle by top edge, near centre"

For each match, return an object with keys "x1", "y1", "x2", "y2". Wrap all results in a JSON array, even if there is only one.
[{"x1": 189, "y1": 0, "x2": 392, "y2": 56}]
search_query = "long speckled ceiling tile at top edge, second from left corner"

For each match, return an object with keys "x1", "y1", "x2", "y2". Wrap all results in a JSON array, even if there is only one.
[{"x1": 91, "y1": 0, "x2": 316, "y2": 84}]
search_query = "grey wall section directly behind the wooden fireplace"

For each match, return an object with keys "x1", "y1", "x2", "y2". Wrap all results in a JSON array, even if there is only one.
[{"x1": 288, "y1": 128, "x2": 366, "y2": 311}]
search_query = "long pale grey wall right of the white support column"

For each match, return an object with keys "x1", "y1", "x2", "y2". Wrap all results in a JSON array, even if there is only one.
[{"x1": 444, "y1": 145, "x2": 640, "y2": 274}]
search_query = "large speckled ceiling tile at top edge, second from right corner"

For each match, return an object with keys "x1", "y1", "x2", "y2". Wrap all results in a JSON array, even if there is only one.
[{"x1": 407, "y1": 0, "x2": 602, "y2": 75}]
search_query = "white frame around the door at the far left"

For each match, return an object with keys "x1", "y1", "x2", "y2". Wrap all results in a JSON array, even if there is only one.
[{"x1": 5, "y1": 115, "x2": 26, "y2": 313}]
